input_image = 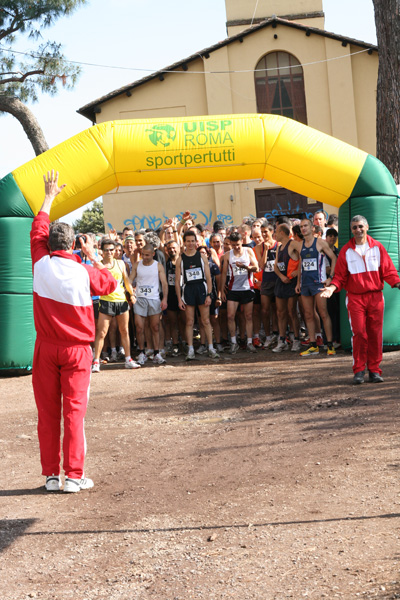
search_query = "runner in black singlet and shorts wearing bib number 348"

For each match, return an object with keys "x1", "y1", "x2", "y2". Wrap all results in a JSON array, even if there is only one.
[{"x1": 175, "y1": 230, "x2": 219, "y2": 360}]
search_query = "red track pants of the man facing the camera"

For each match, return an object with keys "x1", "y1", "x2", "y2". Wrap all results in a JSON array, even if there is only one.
[{"x1": 346, "y1": 292, "x2": 385, "y2": 374}]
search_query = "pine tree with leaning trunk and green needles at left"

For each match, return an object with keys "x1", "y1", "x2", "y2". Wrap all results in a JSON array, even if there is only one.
[{"x1": 0, "y1": 0, "x2": 86, "y2": 155}]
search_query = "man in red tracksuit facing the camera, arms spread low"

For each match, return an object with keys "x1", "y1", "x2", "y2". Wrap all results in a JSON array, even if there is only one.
[{"x1": 321, "y1": 215, "x2": 400, "y2": 384}]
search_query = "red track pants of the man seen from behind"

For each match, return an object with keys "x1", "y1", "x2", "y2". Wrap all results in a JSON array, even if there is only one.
[{"x1": 32, "y1": 341, "x2": 92, "y2": 479}]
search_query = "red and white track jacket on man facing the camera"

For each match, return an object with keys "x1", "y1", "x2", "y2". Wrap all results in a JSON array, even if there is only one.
[{"x1": 332, "y1": 235, "x2": 400, "y2": 294}]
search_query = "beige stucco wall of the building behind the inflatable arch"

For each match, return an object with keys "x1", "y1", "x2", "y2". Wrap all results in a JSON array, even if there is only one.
[{"x1": 98, "y1": 19, "x2": 378, "y2": 229}]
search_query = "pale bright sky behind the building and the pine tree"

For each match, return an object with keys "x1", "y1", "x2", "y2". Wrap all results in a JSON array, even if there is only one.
[{"x1": 0, "y1": 0, "x2": 376, "y2": 223}]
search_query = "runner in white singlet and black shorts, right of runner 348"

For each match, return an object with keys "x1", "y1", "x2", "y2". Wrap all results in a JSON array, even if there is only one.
[{"x1": 219, "y1": 225, "x2": 258, "y2": 354}]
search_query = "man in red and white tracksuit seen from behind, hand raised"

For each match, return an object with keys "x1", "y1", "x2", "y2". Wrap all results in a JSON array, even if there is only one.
[{"x1": 31, "y1": 171, "x2": 117, "y2": 492}]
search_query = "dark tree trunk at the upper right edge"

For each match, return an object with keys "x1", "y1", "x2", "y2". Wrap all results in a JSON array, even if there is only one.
[{"x1": 373, "y1": 0, "x2": 400, "y2": 184}]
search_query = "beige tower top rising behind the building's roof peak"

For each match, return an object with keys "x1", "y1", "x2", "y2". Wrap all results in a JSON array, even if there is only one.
[{"x1": 225, "y1": 0, "x2": 325, "y2": 36}]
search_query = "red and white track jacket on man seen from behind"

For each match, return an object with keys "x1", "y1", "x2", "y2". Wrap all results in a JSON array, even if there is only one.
[{"x1": 31, "y1": 212, "x2": 117, "y2": 346}]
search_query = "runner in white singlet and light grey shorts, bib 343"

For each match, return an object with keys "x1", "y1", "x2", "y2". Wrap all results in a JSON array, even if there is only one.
[{"x1": 129, "y1": 244, "x2": 168, "y2": 365}]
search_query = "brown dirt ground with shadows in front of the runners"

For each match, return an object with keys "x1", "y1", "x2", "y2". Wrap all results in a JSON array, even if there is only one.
[{"x1": 0, "y1": 351, "x2": 400, "y2": 600}]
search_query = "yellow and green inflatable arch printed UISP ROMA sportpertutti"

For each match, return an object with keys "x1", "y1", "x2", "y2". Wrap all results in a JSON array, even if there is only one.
[{"x1": 0, "y1": 114, "x2": 400, "y2": 370}]
